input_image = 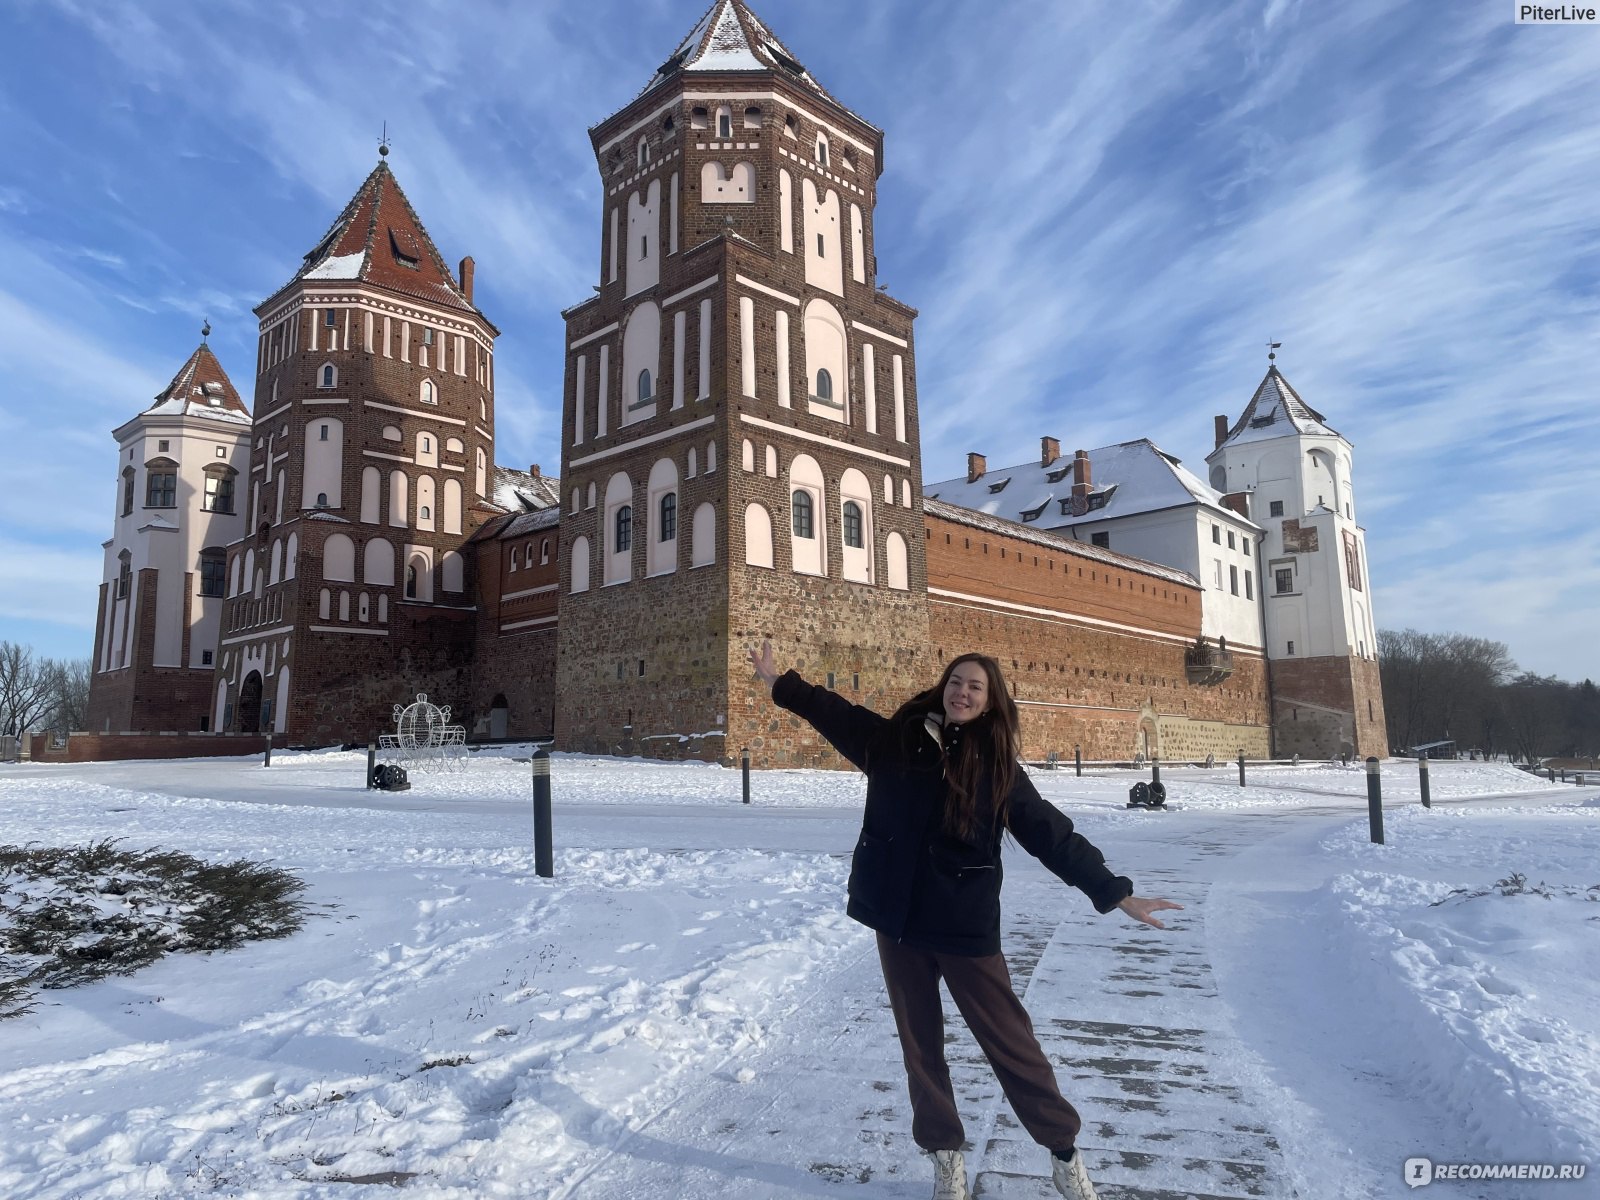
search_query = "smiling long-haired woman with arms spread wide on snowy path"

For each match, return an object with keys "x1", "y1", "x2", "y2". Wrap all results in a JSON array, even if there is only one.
[{"x1": 750, "y1": 642, "x2": 1182, "y2": 1200}]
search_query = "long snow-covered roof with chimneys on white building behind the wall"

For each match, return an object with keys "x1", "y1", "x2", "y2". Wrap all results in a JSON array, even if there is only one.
[{"x1": 922, "y1": 438, "x2": 1250, "y2": 530}]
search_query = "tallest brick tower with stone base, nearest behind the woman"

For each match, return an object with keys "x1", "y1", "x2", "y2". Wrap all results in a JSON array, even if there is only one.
[{"x1": 557, "y1": 0, "x2": 928, "y2": 765}]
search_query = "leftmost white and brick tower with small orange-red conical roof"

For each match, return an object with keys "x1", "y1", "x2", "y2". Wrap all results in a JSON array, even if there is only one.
[{"x1": 86, "y1": 339, "x2": 250, "y2": 733}]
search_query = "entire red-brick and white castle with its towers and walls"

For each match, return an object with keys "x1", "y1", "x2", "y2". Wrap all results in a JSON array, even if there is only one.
[{"x1": 78, "y1": 0, "x2": 1387, "y2": 766}]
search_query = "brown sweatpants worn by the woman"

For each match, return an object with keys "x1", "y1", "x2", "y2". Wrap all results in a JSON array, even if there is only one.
[{"x1": 878, "y1": 933, "x2": 1083, "y2": 1150}]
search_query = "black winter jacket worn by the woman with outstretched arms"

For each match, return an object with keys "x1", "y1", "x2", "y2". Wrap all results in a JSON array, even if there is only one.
[{"x1": 773, "y1": 670, "x2": 1133, "y2": 955}]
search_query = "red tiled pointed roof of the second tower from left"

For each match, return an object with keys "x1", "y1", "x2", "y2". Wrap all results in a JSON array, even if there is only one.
[{"x1": 256, "y1": 160, "x2": 482, "y2": 315}]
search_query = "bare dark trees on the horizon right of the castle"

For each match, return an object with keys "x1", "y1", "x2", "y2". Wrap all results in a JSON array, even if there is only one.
[{"x1": 1378, "y1": 629, "x2": 1600, "y2": 762}]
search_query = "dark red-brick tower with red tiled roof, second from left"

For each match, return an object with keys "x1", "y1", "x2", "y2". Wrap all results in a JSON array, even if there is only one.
[{"x1": 214, "y1": 149, "x2": 499, "y2": 744}]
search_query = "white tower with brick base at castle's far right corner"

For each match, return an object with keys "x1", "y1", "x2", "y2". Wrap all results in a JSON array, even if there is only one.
[{"x1": 1206, "y1": 365, "x2": 1389, "y2": 758}]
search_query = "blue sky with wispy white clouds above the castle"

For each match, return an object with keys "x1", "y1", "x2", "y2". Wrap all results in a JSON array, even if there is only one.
[{"x1": 0, "y1": 0, "x2": 1600, "y2": 678}]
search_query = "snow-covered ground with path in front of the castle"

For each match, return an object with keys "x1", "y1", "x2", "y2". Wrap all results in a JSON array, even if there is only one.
[{"x1": 0, "y1": 749, "x2": 1600, "y2": 1200}]
